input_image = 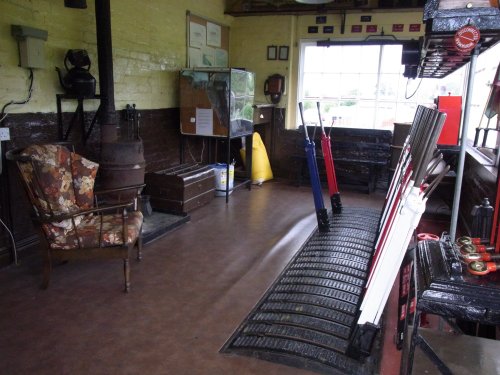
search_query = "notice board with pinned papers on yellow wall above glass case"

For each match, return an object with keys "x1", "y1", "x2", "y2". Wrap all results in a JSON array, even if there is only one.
[{"x1": 186, "y1": 11, "x2": 229, "y2": 68}]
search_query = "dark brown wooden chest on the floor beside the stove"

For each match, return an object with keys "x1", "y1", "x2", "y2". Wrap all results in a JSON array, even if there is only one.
[{"x1": 144, "y1": 164, "x2": 215, "y2": 213}]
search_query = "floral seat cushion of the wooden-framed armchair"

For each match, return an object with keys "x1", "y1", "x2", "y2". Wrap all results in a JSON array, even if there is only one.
[{"x1": 42, "y1": 211, "x2": 143, "y2": 250}]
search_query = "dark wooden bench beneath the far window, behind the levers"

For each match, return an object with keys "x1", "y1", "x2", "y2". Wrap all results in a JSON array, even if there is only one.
[{"x1": 292, "y1": 128, "x2": 392, "y2": 193}]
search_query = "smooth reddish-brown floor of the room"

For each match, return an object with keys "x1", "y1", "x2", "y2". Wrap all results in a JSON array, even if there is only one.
[{"x1": 0, "y1": 182, "x2": 399, "y2": 375}]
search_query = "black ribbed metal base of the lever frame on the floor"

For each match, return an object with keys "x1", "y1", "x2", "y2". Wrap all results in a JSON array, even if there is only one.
[{"x1": 221, "y1": 208, "x2": 380, "y2": 375}]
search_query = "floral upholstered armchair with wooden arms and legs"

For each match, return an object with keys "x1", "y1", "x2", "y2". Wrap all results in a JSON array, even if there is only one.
[{"x1": 7, "y1": 144, "x2": 144, "y2": 292}]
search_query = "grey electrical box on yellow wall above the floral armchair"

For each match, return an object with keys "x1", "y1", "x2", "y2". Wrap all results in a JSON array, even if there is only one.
[{"x1": 11, "y1": 25, "x2": 48, "y2": 68}]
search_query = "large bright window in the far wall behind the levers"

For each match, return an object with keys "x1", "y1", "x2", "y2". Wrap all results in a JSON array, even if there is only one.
[{"x1": 297, "y1": 41, "x2": 462, "y2": 130}]
